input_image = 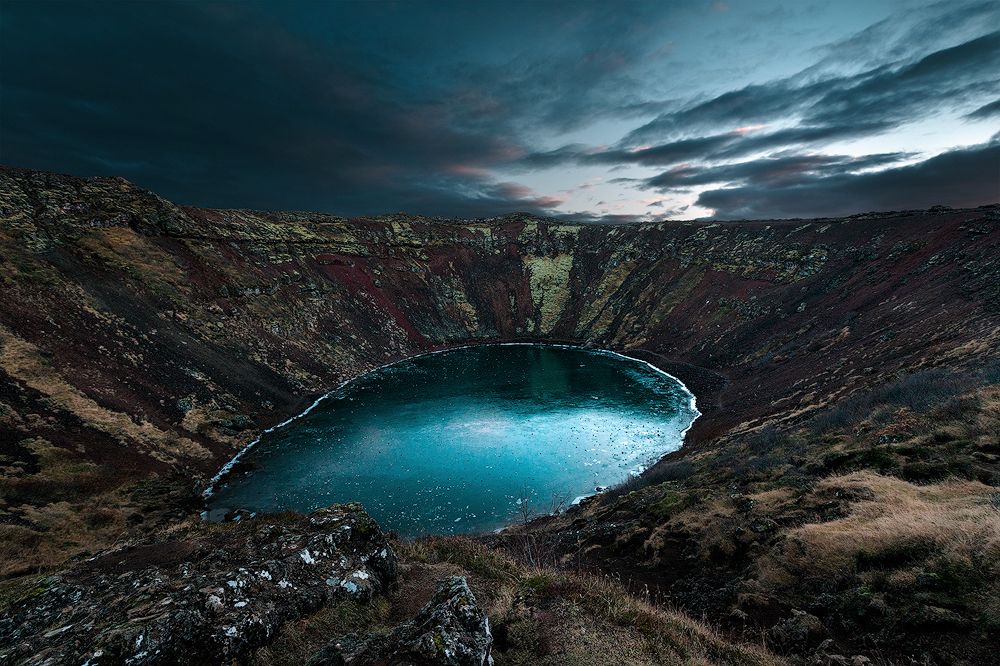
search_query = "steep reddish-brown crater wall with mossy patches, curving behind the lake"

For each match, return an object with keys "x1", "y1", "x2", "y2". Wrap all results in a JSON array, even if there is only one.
[{"x1": 0, "y1": 168, "x2": 1000, "y2": 572}]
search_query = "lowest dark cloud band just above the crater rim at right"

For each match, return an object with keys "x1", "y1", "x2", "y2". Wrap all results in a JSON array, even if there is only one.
[{"x1": 696, "y1": 137, "x2": 1000, "y2": 220}]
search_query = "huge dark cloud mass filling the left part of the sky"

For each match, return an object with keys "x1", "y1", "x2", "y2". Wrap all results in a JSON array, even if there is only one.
[{"x1": 2, "y1": 2, "x2": 712, "y2": 214}]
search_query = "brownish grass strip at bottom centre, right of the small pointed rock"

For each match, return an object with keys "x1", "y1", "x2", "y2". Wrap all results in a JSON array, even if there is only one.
[{"x1": 386, "y1": 537, "x2": 784, "y2": 666}]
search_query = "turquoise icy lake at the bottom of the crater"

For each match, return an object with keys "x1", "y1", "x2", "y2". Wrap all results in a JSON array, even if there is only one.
[{"x1": 209, "y1": 345, "x2": 698, "y2": 536}]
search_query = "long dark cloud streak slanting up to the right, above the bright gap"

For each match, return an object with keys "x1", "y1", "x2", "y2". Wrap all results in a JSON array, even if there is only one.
[{"x1": 521, "y1": 27, "x2": 1000, "y2": 168}]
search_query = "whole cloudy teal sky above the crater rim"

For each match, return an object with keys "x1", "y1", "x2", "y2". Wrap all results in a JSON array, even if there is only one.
[{"x1": 0, "y1": 0, "x2": 1000, "y2": 222}]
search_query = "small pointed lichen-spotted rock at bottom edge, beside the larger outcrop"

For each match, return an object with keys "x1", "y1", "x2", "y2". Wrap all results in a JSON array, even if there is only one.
[{"x1": 307, "y1": 576, "x2": 493, "y2": 666}]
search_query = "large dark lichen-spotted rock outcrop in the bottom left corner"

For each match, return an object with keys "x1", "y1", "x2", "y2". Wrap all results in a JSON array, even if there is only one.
[{"x1": 0, "y1": 504, "x2": 397, "y2": 666}]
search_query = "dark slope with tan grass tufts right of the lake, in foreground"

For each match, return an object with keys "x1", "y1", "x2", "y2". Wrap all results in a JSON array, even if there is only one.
[{"x1": 485, "y1": 363, "x2": 1000, "y2": 664}]
